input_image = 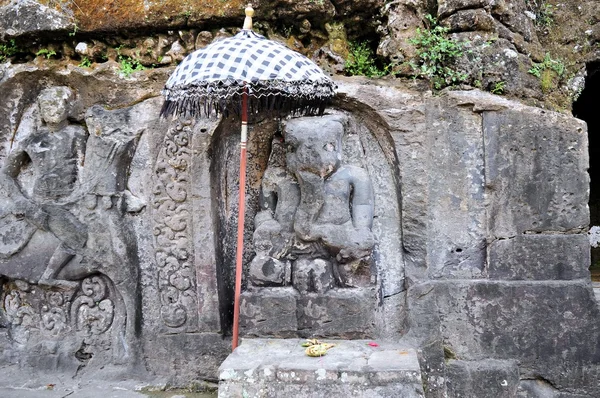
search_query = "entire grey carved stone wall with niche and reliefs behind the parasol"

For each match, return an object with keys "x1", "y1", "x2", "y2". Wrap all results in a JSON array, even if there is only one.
[{"x1": 0, "y1": 65, "x2": 600, "y2": 398}]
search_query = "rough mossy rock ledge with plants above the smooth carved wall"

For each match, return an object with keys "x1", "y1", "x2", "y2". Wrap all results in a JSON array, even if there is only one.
[{"x1": 0, "y1": 0, "x2": 600, "y2": 112}]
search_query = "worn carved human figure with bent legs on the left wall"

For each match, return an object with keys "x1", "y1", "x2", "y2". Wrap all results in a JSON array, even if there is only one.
[{"x1": 0, "y1": 87, "x2": 87, "y2": 286}]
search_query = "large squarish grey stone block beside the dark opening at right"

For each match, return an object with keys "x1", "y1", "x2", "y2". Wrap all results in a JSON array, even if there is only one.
[{"x1": 483, "y1": 108, "x2": 589, "y2": 238}]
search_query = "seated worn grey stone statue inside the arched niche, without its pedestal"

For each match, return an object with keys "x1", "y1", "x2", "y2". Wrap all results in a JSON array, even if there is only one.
[{"x1": 249, "y1": 115, "x2": 375, "y2": 293}]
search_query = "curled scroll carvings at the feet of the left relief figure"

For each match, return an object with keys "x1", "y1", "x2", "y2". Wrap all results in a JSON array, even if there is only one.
[{"x1": 1, "y1": 275, "x2": 123, "y2": 365}]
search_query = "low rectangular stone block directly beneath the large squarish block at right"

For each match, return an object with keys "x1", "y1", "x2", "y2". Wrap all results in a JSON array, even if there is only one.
[{"x1": 488, "y1": 234, "x2": 590, "y2": 280}]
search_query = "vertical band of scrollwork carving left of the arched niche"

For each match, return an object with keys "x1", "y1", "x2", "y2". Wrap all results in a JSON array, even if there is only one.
[{"x1": 152, "y1": 120, "x2": 198, "y2": 331}]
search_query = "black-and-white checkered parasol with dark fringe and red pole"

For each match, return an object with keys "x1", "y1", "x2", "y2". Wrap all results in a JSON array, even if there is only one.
[{"x1": 161, "y1": 4, "x2": 335, "y2": 349}]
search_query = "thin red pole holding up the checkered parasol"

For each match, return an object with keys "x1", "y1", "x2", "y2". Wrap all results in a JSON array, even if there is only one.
[{"x1": 232, "y1": 86, "x2": 248, "y2": 351}]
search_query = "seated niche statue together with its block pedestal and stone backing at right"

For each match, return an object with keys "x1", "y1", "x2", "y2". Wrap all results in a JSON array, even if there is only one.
[{"x1": 241, "y1": 112, "x2": 403, "y2": 338}]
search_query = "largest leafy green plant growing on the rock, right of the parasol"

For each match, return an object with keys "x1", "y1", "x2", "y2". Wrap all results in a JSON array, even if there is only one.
[{"x1": 409, "y1": 14, "x2": 467, "y2": 90}]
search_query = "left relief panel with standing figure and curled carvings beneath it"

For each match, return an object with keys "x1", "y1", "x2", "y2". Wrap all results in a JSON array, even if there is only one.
[{"x1": 0, "y1": 87, "x2": 144, "y2": 363}]
